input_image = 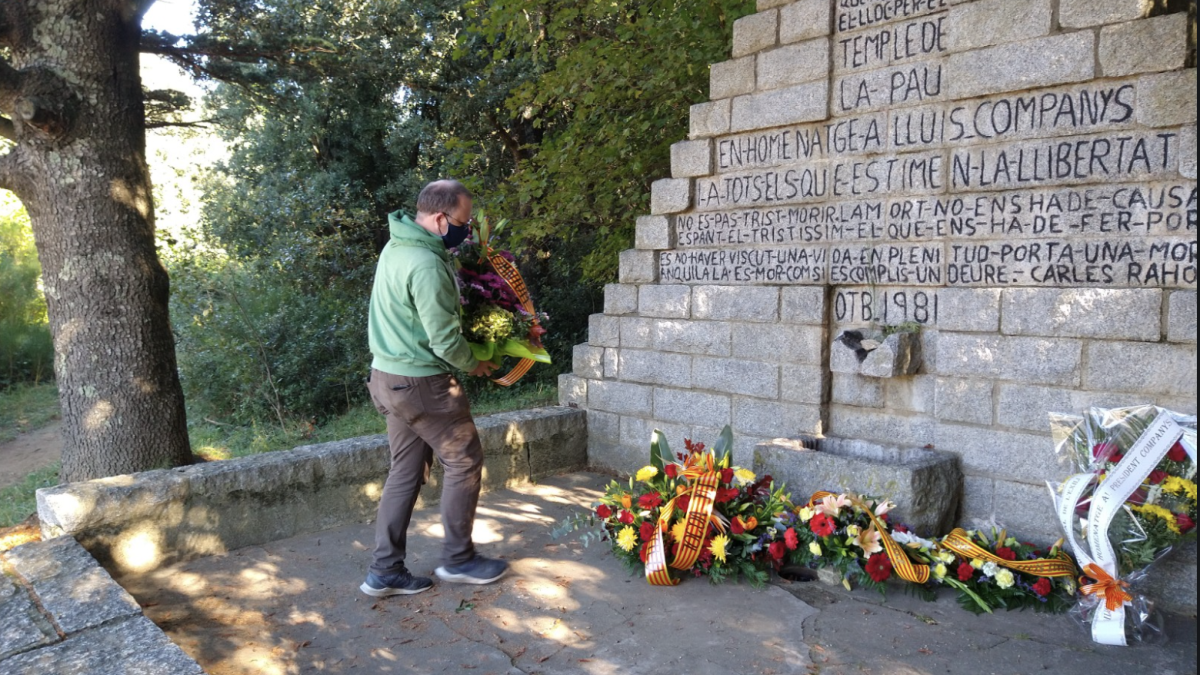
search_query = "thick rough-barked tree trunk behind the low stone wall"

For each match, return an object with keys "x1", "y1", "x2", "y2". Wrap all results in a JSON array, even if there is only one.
[{"x1": 0, "y1": 0, "x2": 191, "y2": 482}]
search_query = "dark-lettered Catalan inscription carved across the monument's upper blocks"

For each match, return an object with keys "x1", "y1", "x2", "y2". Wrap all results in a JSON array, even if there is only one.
[{"x1": 659, "y1": 0, "x2": 1198, "y2": 291}]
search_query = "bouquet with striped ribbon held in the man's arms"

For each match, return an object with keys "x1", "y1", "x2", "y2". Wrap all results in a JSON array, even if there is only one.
[{"x1": 455, "y1": 213, "x2": 550, "y2": 374}]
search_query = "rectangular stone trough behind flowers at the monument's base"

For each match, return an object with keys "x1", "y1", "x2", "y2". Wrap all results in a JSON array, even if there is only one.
[{"x1": 754, "y1": 438, "x2": 962, "y2": 534}]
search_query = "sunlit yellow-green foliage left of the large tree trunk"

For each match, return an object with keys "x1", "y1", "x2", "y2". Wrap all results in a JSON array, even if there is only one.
[{"x1": 0, "y1": 192, "x2": 54, "y2": 388}]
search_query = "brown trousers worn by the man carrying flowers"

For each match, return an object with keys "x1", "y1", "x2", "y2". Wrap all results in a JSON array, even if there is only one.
[{"x1": 367, "y1": 369, "x2": 484, "y2": 575}]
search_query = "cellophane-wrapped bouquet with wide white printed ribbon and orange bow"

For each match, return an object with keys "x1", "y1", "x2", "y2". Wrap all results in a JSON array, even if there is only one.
[{"x1": 1049, "y1": 406, "x2": 1196, "y2": 645}]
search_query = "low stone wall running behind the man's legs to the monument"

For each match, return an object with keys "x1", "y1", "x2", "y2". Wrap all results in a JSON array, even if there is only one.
[{"x1": 37, "y1": 407, "x2": 587, "y2": 577}]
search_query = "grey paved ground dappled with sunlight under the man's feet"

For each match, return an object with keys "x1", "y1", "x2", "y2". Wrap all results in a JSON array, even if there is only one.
[{"x1": 120, "y1": 473, "x2": 1196, "y2": 675}]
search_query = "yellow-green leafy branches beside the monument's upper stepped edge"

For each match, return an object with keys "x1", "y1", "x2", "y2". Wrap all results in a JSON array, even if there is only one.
[{"x1": 454, "y1": 0, "x2": 755, "y2": 283}]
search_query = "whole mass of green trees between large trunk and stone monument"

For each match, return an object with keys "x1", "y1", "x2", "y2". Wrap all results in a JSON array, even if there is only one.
[{"x1": 162, "y1": 0, "x2": 754, "y2": 429}]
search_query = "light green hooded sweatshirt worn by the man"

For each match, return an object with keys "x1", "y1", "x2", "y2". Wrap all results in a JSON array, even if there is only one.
[{"x1": 367, "y1": 211, "x2": 479, "y2": 377}]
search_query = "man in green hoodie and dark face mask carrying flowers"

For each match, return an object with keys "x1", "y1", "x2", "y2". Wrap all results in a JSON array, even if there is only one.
[{"x1": 359, "y1": 180, "x2": 508, "y2": 597}]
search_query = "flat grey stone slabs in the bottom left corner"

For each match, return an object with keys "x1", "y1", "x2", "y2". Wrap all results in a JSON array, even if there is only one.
[{"x1": 0, "y1": 537, "x2": 204, "y2": 675}]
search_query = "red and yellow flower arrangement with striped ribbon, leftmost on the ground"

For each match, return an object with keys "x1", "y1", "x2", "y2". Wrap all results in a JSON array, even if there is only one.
[{"x1": 554, "y1": 426, "x2": 799, "y2": 586}]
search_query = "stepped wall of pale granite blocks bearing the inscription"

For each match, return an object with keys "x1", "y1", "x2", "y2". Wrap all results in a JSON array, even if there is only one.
[{"x1": 560, "y1": 0, "x2": 1196, "y2": 552}]
